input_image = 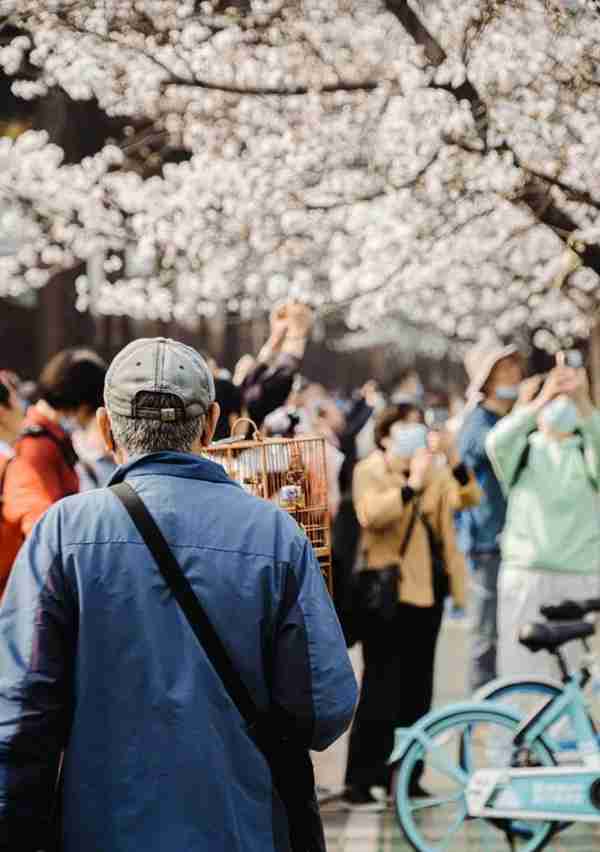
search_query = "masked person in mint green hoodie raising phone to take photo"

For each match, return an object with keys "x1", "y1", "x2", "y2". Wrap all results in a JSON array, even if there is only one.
[{"x1": 486, "y1": 365, "x2": 600, "y2": 677}]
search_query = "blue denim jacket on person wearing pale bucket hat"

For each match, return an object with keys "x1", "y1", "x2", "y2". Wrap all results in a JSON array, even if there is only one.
[{"x1": 457, "y1": 405, "x2": 506, "y2": 554}]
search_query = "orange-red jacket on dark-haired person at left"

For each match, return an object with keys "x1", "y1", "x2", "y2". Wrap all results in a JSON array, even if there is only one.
[{"x1": 4, "y1": 408, "x2": 79, "y2": 537}]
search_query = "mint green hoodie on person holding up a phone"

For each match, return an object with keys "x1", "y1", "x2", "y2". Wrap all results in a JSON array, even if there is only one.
[{"x1": 486, "y1": 406, "x2": 600, "y2": 574}]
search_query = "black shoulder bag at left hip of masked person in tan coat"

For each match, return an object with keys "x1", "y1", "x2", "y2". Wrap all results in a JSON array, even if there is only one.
[{"x1": 353, "y1": 501, "x2": 419, "y2": 638}]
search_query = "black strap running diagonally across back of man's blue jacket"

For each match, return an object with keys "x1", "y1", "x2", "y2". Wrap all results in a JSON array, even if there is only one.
[{"x1": 110, "y1": 482, "x2": 260, "y2": 728}]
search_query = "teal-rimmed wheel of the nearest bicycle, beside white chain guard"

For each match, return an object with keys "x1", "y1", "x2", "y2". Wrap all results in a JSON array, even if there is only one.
[{"x1": 394, "y1": 705, "x2": 555, "y2": 852}]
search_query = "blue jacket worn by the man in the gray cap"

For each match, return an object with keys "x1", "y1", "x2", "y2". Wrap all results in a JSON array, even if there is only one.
[{"x1": 0, "y1": 453, "x2": 357, "y2": 852}]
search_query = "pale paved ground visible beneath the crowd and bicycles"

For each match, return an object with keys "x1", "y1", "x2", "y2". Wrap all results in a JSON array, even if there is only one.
[{"x1": 315, "y1": 621, "x2": 600, "y2": 852}]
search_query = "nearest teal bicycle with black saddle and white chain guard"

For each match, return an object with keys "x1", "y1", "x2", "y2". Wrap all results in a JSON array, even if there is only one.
[{"x1": 390, "y1": 621, "x2": 600, "y2": 852}]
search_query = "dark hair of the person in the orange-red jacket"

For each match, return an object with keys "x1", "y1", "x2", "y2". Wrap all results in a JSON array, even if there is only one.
[{"x1": 39, "y1": 349, "x2": 106, "y2": 411}]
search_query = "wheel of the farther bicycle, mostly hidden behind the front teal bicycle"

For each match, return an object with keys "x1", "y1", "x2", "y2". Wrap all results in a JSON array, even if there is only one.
[{"x1": 476, "y1": 678, "x2": 593, "y2": 763}]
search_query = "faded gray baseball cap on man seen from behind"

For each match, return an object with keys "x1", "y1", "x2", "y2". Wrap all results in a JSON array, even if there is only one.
[{"x1": 104, "y1": 337, "x2": 215, "y2": 422}]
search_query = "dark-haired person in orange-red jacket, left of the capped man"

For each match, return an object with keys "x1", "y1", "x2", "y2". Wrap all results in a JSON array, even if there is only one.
[{"x1": 3, "y1": 349, "x2": 106, "y2": 556}]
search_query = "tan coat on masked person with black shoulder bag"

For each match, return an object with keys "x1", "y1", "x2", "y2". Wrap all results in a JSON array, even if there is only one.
[{"x1": 353, "y1": 450, "x2": 481, "y2": 606}]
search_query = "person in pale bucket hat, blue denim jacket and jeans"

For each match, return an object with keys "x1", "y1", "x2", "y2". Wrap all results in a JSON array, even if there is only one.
[{"x1": 458, "y1": 340, "x2": 523, "y2": 691}]
